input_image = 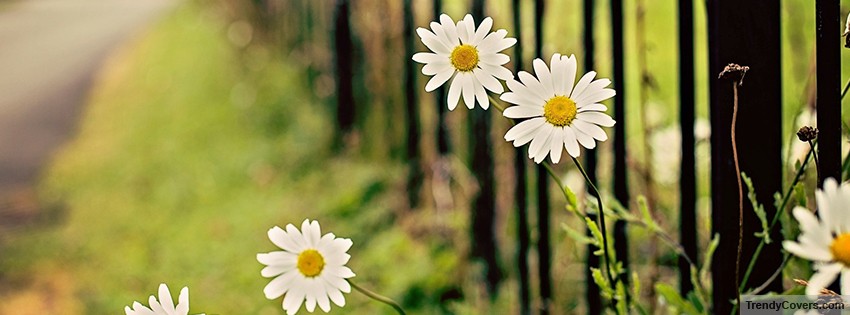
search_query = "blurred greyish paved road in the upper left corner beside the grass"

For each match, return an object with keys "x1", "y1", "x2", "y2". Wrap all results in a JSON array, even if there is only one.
[{"x1": 0, "y1": 0, "x2": 175, "y2": 195}]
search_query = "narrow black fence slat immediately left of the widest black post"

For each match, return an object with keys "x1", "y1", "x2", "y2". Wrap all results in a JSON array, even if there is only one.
[{"x1": 679, "y1": 0, "x2": 698, "y2": 296}]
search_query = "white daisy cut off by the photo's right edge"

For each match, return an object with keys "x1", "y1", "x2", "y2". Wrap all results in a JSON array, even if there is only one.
[{"x1": 782, "y1": 178, "x2": 850, "y2": 295}]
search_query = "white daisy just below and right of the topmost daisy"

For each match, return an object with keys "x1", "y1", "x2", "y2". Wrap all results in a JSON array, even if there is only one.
[{"x1": 501, "y1": 54, "x2": 617, "y2": 163}]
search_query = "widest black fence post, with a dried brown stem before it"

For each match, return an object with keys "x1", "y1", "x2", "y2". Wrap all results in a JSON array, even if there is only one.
[{"x1": 707, "y1": 0, "x2": 780, "y2": 314}]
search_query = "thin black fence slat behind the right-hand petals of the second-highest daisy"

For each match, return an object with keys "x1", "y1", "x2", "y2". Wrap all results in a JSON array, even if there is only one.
[{"x1": 582, "y1": 0, "x2": 602, "y2": 315}]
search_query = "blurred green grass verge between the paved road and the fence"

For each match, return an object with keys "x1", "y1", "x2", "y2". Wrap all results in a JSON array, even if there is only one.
[{"x1": 0, "y1": 5, "x2": 462, "y2": 314}]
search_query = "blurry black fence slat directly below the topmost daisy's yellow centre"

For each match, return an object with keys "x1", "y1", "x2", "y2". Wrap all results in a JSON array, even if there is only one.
[{"x1": 469, "y1": 0, "x2": 502, "y2": 297}]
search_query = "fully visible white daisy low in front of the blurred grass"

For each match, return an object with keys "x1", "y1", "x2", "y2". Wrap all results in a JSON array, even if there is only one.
[{"x1": 257, "y1": 220, "x2": 354, "y2": 315}]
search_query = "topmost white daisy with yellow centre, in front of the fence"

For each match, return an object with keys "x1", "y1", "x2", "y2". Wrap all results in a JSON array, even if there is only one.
[{"x1": 413, "y1": 14, "x2": 516, "y2": 110}]
